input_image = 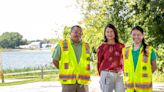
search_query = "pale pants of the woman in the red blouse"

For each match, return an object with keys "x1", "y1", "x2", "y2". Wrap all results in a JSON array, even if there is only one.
[{"x1": 100, "y1": 71, "x2": 125, "y2": 92}]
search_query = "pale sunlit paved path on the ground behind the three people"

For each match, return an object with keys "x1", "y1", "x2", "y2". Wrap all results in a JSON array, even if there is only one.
[{"x1": 0, "y1": 77, "x2": 164, "y2": 92}]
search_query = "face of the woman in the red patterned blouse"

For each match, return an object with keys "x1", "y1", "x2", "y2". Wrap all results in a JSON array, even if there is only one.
[{"x1": 105, "y1": 27, "x2": 115, "y2": 40}]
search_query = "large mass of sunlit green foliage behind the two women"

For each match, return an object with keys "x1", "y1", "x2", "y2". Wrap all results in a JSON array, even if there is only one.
[{"x1": 77, "y1": 0, "x2": 164, "y2": 71}]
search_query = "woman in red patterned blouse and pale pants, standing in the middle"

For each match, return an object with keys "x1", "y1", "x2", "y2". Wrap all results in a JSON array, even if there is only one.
[{"x1": 97, "y1": 24, "x2": 124, "y2": 92}]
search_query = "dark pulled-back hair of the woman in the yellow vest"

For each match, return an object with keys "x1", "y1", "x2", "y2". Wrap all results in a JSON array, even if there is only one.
[{"x1": 131, "y1": 26, "x2": 147, "y2": 55}]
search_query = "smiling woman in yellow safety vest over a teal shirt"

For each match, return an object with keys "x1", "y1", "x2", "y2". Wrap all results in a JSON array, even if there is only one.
[{"x1": 123, "y1": 26, "x2": 157, "y2": 92}]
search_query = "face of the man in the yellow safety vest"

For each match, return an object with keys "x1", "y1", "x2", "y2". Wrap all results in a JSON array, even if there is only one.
[{"x1": 70, "y1": 27, "x2": 83, "y2": 43}]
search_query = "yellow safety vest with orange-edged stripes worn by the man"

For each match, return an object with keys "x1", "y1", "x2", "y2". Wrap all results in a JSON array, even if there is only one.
[{"x1": 59, "y1": 40, "x2": 90, "y2": 84}]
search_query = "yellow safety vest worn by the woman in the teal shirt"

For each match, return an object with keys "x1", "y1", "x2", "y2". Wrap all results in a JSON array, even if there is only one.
[{"x1": 123, "y1": 46, "x2": 153, "y2": 92}]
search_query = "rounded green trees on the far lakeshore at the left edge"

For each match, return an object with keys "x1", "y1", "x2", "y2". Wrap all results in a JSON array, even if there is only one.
[{"x1": 0, "y1": 32, "x2": 27, "y2": 48}]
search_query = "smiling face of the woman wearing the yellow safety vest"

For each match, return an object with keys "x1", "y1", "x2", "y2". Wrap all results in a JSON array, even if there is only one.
[{"x1": 131, "y1": 29, "x2": 143, "y2": 44}]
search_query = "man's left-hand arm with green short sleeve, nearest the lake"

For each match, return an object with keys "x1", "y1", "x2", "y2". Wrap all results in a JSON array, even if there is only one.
[{"x1": 52, "y1": 44, "x2": 61, "y2": 69}]
